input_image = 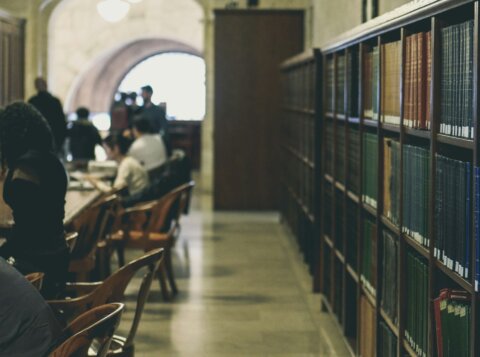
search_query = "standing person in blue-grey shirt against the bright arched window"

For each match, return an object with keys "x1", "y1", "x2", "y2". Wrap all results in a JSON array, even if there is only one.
[{"x1": 136, "y1": 85, "x2": 172, "y2": 156}]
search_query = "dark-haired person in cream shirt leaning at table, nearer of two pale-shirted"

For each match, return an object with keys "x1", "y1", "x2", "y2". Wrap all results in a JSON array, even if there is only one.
[{"x1": 103, "y1": 134, "x2": 150, "y2": 195}]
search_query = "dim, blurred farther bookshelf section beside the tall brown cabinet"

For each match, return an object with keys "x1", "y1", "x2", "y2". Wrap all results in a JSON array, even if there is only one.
[{"x1": 280, "y1": 50, "x2": 321, "y2": 278}]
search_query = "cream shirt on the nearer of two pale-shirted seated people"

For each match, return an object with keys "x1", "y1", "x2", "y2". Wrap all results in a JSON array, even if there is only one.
[{"x1": 113, "y1": 156, "x2": 150, "y2": 195}]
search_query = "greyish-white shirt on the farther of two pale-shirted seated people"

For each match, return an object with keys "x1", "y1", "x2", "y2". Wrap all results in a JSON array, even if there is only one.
[{"x1": 128, "y1": 134, "x2": 167, "y2": 171}]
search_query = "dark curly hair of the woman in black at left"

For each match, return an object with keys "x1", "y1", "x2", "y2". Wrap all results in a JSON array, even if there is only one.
[{"x1": 0, "y1": 102, "x2": 54, "y2": 169}]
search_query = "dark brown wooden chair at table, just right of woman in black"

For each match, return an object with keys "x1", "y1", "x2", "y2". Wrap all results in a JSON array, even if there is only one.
[{"x1": 68, "y1": 195, "x2": 118, "y2": 281}]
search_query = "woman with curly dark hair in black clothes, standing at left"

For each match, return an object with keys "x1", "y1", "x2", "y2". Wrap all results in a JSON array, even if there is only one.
[{"x1": 0, "y1": 102, "x2": 69, "y2": 298}]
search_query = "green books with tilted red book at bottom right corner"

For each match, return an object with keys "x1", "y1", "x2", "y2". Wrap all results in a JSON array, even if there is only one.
[{"x1": 433, "y1": 289, "x2": 471, "y2": 357}]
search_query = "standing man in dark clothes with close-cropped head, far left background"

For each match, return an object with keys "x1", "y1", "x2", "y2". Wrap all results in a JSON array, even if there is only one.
[{"x1": 28, "y1": 77, "x2": 67, "y2": 152}]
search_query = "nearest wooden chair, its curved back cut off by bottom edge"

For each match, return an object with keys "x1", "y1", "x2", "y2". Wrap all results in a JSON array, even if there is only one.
[{"x1": 50, "y1": 303, "x2": 124, "y2": 357}]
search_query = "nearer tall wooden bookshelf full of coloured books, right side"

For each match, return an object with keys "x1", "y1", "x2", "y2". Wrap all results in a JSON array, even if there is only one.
[{"x1": 283, "y1": 0, "x2": 480, "y2": 356}]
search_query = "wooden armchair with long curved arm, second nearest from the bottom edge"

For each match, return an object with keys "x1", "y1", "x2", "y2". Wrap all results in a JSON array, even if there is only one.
[{"x1": 48, "y1": 248, "x2": 164, "y2": 356}]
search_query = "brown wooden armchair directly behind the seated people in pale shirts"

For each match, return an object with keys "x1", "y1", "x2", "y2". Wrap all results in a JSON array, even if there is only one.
[{"x1": 111, "y1": 181, "x2": 195, "y2": 301}]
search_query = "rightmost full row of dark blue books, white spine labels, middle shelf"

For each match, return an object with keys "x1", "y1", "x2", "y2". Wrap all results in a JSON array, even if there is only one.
[{"x1": 434, "y1": 154, "x2": 472, "y2": 279}]
